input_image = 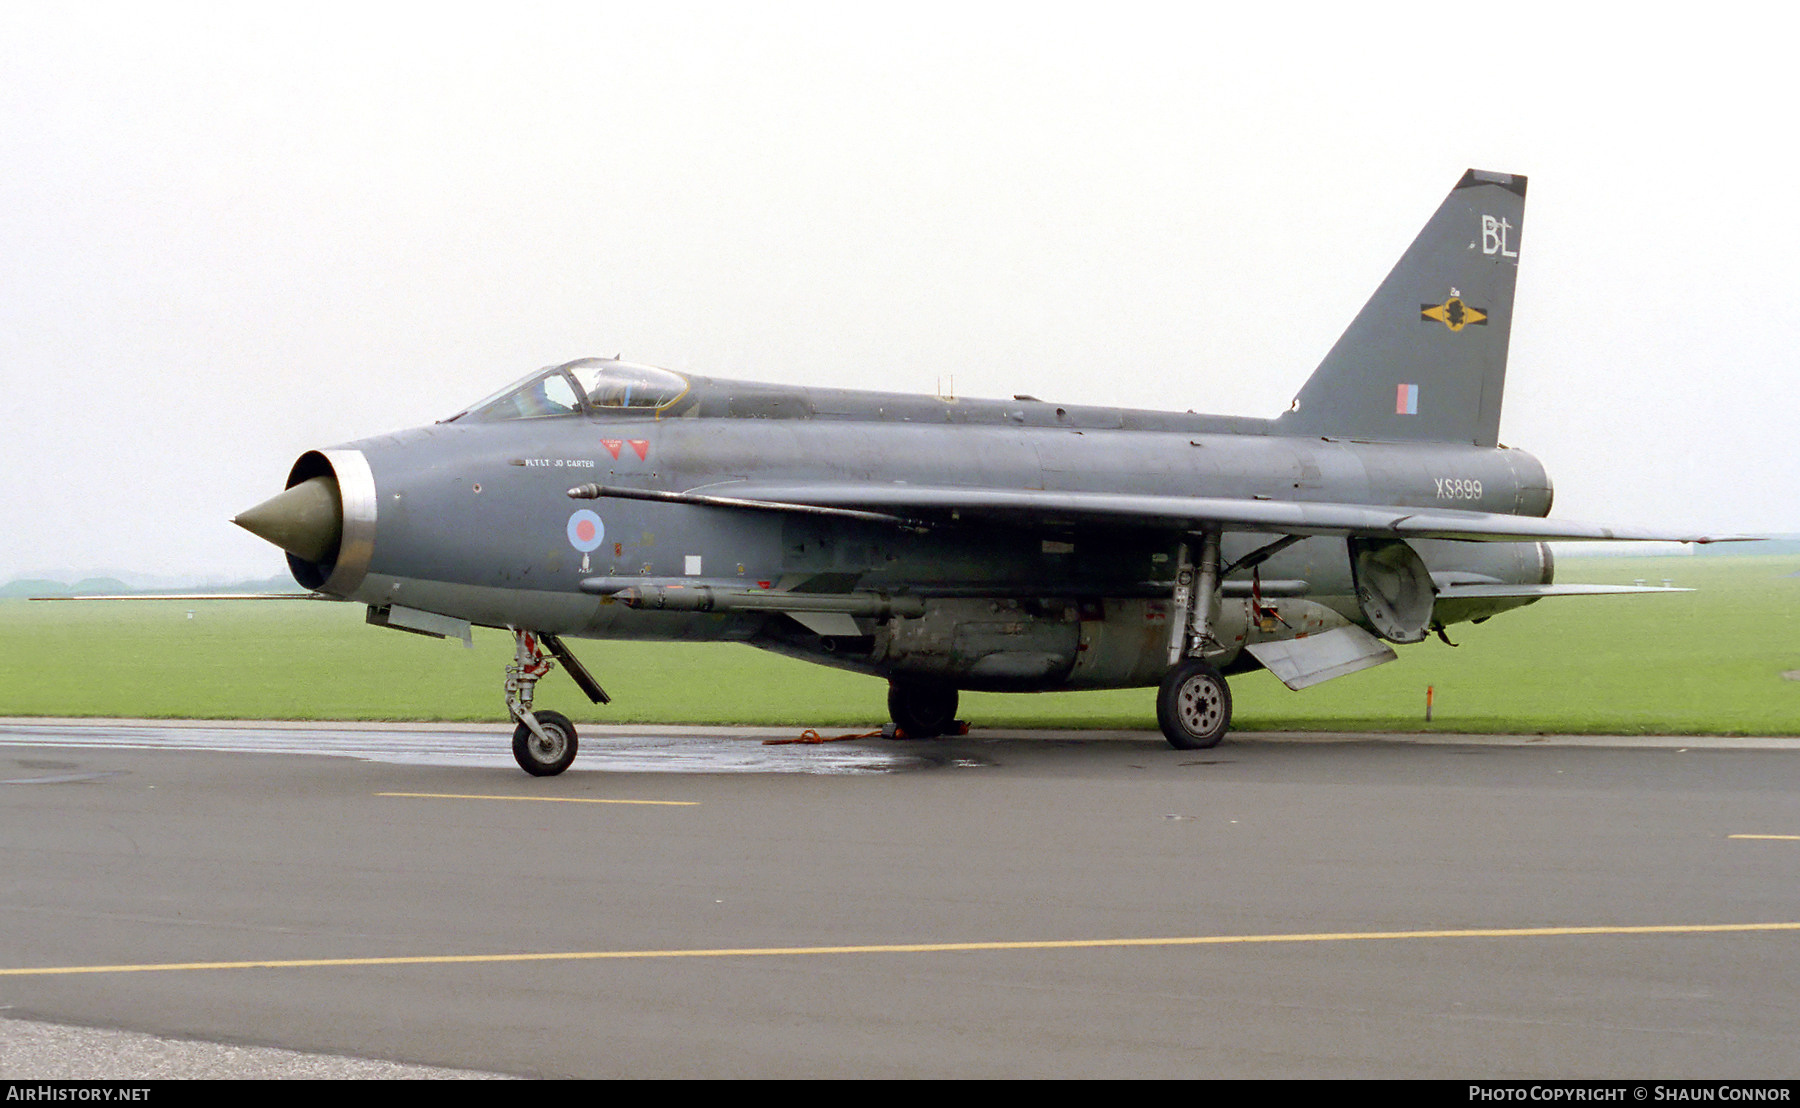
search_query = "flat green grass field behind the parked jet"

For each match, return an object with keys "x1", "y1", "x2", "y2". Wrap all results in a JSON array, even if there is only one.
[{"x1": 0, "y1": 554, "x2": 1800, "y2": 736}]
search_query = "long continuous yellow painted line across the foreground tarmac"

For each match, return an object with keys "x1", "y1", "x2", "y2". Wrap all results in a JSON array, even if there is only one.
[{"x1": 0, "y1": 923, "x2": 1800, "y2": 977}]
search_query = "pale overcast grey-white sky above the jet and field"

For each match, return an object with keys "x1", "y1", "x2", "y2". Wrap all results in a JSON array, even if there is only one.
[{"x1": 0, "y1": 0, "x2": 1800, "y2": 581}]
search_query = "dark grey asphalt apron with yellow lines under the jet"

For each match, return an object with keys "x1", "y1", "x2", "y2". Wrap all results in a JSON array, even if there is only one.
[{"x1": 0, "y1": 719, "x2": 1800, "y2": 1077}]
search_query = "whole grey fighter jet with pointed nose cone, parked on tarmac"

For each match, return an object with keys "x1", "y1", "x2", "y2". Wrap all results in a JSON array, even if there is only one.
[{"x1": 236, "y1": 169, "x2": 1723, "y2": 775}]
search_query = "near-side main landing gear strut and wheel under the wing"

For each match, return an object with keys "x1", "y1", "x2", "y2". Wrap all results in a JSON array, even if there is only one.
[{"x1": 1156, "y1": 527, "x2": 1231, "y2": 750}]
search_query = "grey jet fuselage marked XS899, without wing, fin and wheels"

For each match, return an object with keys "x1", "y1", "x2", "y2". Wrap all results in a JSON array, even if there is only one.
[{"x1": 273, "y1": 360, "x2": 1552, "y2": 689}]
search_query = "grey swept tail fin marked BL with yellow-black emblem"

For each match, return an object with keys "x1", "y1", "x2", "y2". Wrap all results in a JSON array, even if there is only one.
[{"x1": 1276, "y1": 169, "x2": 1525, "y2": 446}]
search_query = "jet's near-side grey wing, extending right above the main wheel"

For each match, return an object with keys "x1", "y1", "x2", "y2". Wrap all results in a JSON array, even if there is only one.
[{"x1": 590, "y1": 482, "x2": 1750, "y2": 543}]
